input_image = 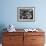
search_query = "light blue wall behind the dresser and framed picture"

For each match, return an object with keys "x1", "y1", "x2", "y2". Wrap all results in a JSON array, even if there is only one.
[{"x1": 0, "y1": 0, "x2": 46, "y2": 43}]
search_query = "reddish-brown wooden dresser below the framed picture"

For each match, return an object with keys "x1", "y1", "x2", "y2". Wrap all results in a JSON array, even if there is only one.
[{"x1": 2, "y1": 32, "x2": 44, "y2": 46}]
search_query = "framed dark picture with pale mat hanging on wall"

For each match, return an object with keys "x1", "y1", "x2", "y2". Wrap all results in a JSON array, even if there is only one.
[{"x1": 17, "y1": 7, "x2": 35, "y2": 22}]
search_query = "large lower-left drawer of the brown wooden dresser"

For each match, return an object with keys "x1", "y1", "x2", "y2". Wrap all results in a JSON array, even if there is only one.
[{"x1": 3, "y1": 36, "x2": 23, "y2": 43}]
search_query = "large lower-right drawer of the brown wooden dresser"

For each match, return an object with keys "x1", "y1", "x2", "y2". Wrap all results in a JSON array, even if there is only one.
[{"x1": 24, "y1": 35, "x2": 44, "y2": 46}]
